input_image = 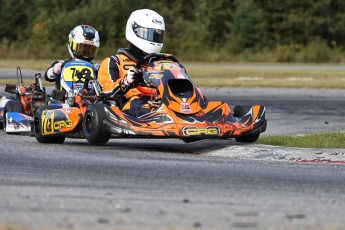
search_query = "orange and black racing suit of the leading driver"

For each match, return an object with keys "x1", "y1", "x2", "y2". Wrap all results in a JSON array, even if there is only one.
[{"x1": 97, "y1": 46, "x2": 155, "y2": 117}]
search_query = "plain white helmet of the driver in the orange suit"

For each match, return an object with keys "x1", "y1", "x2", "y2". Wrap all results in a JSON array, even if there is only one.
[{"x1": 126, "y1": 9, "x2": 165, "y2": 53}]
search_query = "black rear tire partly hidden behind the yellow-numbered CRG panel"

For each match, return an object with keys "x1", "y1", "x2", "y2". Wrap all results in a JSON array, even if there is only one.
[{"x1": 34, "y1": 105, "x2": 66, "y2": 144}]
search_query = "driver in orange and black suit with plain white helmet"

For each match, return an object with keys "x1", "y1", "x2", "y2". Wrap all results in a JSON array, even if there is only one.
[{"x1": 97, "y1": 9, "x2": 165, "y2": 117}]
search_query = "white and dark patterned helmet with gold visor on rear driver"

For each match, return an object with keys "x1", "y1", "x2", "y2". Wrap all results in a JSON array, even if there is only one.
[{"x1": 68, "y1": 25, "x2": 100, "y2": 61}]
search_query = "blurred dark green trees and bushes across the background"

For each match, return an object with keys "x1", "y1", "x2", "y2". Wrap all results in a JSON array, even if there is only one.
[{"x1": 0, "y1": 0, "x2": 345, "y2": 63}]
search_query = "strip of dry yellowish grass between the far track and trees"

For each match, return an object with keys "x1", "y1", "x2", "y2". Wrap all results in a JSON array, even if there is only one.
[{"x1": 0, "y1": 59, "x2": 345, "y2": 89}]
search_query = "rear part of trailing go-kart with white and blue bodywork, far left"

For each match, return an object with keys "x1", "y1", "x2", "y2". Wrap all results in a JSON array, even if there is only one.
[{"x1": 0, "y1": 67, "x2": 46, "y2": 133}]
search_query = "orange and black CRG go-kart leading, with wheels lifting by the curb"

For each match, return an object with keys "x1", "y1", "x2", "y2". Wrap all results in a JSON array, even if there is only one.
[{"x1": 35, "y1": 54, "x2": 267, "y2": 144}]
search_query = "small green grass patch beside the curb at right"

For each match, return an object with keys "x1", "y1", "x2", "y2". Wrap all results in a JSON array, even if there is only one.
[{"x1": 256, "y1": 132, "x2": 345, "y2": 148}]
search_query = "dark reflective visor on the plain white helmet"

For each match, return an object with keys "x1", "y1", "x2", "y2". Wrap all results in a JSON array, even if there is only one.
[{"x1": 132, "y1": 23, "x2": 165, "y2": 43}]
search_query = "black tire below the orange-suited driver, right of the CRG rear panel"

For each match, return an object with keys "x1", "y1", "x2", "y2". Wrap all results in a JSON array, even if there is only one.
[{"x1": 83, "y1": 104, "x2": 111, "y2": 144}]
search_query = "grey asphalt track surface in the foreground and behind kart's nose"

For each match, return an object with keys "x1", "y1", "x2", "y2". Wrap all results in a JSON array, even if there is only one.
[{"x1": 0, "y1": 80, "x2": 345, "y2": 230}]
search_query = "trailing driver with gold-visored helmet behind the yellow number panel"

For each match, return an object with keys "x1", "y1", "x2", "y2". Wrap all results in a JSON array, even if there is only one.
[{"x1": 45, "y1": 25, "x2": 100, "y2": 90}]
